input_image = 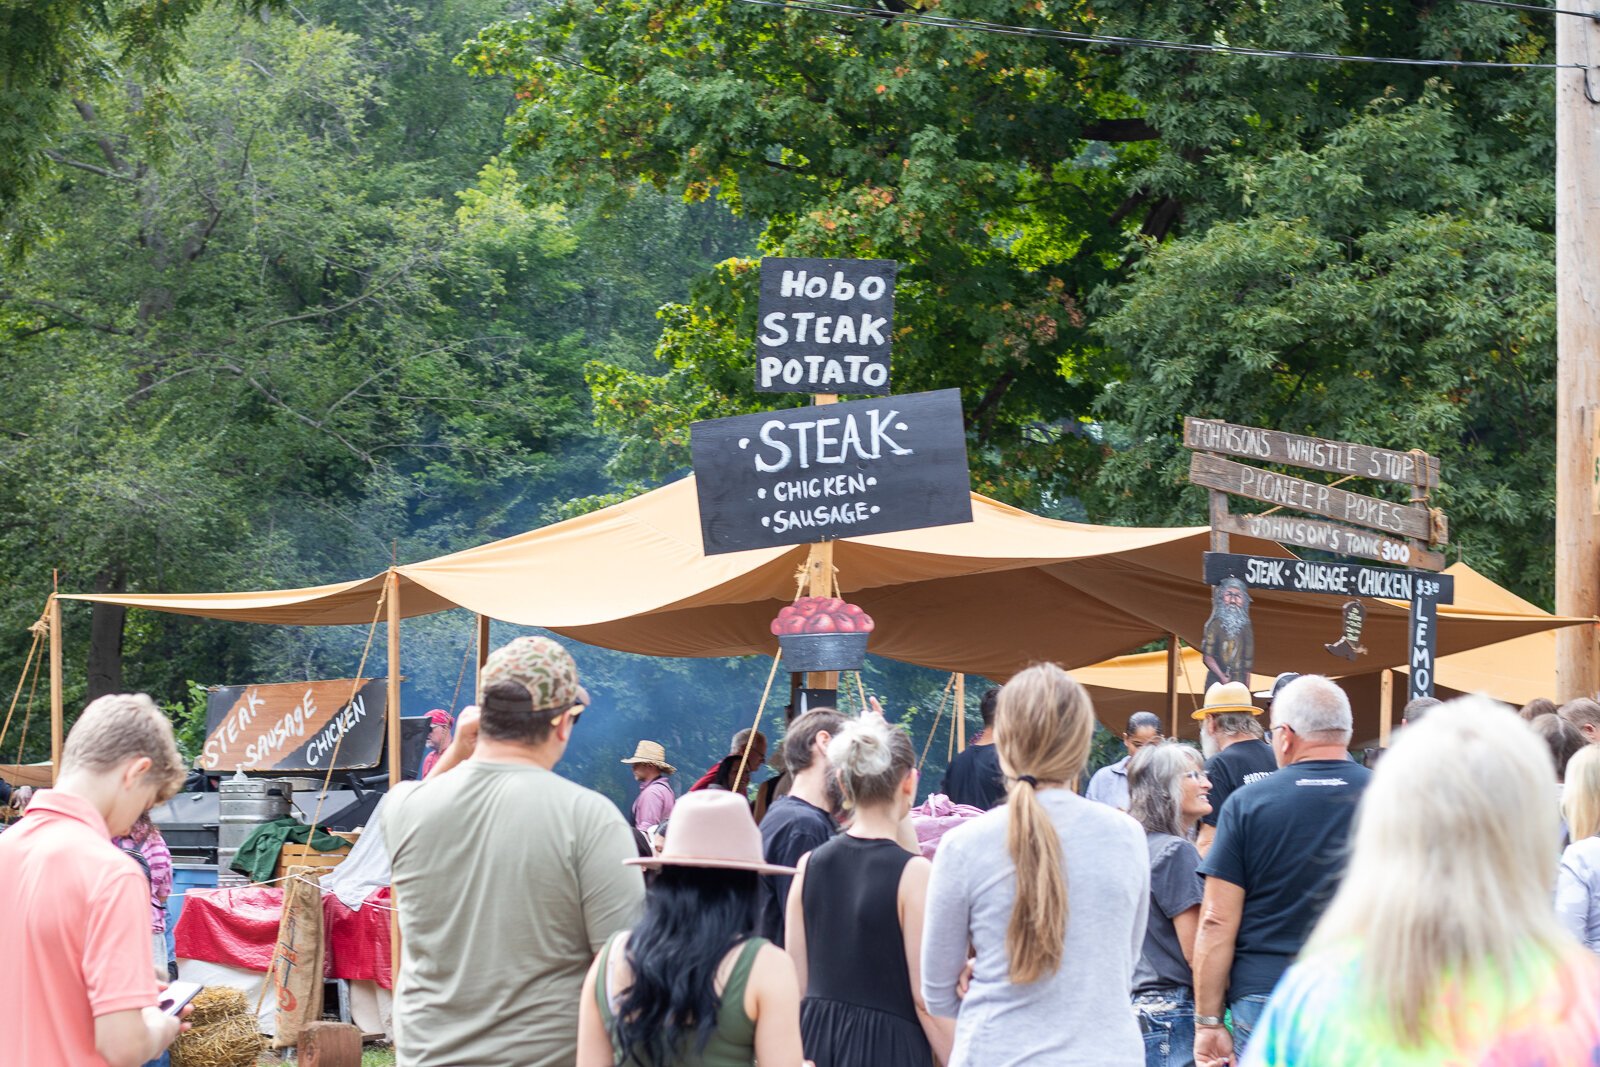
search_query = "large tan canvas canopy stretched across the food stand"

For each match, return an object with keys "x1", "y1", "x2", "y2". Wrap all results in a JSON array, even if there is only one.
[{"x1": 62, "y1": 478, "x2": 1590, "y2": 688}]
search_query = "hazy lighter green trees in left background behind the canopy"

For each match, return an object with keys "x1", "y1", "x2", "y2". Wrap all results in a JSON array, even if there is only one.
[{"x1": 0, "y1": 3, "x2": 742, "y2": 755}]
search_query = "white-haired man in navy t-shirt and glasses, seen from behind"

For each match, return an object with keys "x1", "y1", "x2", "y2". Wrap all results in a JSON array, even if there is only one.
[{"x1": 1194, "y1": 675, "x2": 1371, "y2": 1067}]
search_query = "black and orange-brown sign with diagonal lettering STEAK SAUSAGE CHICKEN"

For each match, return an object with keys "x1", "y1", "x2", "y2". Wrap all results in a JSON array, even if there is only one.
[{"x1": 200, "y1": 678, "x2": 387, "y2": 771}]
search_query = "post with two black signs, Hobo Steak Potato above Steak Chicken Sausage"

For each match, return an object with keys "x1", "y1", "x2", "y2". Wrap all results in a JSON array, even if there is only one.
[{"x1": 690, "y1": 258, "x2": 973, "y2": 693}]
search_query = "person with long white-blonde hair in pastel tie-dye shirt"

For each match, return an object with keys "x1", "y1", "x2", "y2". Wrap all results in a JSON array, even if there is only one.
[{"x1": 1235, "y1": 697, "x2": 1600, "y2": 1067}]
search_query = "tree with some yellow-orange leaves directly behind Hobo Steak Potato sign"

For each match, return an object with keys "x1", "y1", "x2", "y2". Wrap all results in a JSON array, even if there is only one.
[{"x1": 467, "y1": 0, "x2": 1168, "y2": 504}]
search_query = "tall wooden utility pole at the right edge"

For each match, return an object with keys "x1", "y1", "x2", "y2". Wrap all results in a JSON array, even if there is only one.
[{"x1": 1555, "y1": 14, "x2": 1600, "y2": 701}]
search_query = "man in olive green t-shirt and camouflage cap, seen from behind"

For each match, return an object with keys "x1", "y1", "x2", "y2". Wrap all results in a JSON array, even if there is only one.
[{"x1": 381, "y1": 637, "x2": 645, "y2": 1067}]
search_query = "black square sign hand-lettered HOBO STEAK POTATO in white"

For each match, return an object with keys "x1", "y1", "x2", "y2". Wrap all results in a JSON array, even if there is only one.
[{"x1": 755, "y1": 258, "x2": 899, "y2": 397}]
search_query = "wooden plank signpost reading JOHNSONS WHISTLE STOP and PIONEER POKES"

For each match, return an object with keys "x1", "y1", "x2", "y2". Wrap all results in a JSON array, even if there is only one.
[{"x1": 1184, "y1": 419, "x2": 1454, "y2": 710}]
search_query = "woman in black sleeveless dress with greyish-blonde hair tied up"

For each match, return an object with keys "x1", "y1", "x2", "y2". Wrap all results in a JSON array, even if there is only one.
[{"x1": 786, "y1": 715, "x2": 954, "y2": 1067}]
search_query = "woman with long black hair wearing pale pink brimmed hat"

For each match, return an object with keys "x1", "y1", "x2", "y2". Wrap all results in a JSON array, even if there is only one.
[{"x1": 578, "y1": 790, "x2": 802, "y2": 1067}]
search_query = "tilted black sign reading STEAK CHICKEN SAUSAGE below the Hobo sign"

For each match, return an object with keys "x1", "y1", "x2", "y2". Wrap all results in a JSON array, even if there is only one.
[{"x1": 690, "y1": 389, "x2": 973, "y2": 555}]
